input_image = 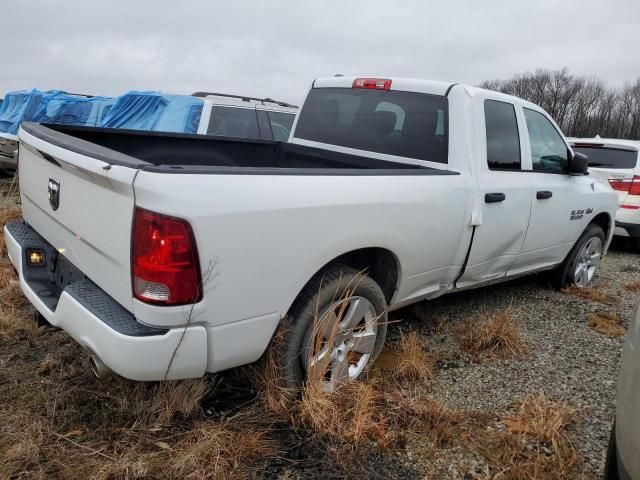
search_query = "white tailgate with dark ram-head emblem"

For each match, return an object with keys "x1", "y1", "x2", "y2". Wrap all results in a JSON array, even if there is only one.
[{"x1": 19, "y1": 124, "x2": 144, "y2": 311}]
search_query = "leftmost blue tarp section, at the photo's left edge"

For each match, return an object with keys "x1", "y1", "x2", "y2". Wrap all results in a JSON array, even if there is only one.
[{"x1": 0, "y1": 89, "x2": 62, "y2": 135}]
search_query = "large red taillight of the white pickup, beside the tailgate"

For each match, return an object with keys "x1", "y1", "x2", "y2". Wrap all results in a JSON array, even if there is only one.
[{"x1": 131, "y1": 208, "x2": 202, "y2": 305}]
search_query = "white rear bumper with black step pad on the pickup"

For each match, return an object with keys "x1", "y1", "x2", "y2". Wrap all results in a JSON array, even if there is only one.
[{"x1": 4, "y1": 220, "x2": 207, "y2": 381}]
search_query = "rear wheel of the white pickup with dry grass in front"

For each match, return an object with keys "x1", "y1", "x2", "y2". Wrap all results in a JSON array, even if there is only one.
[{"x1": 274, "y1": 265, "x2": 387, "y2": 391}]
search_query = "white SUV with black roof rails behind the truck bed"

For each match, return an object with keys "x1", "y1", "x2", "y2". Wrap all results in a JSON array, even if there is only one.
[{"x1": 193, "y1": 92, "x2": 298, "y2": 142}]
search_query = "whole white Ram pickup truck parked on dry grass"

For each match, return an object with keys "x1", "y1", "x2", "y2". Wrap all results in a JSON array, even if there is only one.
[{"x1": 5, "y1": 77, "x2": 616, "y2": 388}]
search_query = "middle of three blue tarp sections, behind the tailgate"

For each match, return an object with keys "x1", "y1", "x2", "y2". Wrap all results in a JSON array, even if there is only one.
[{"x1": 34, "y1": 93, "x2": 116, "y2": 127}]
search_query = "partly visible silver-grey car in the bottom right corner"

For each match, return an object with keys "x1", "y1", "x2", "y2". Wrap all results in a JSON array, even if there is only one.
[{"x1": 605, "y1": 302, "x2": 640, "y2": 480}]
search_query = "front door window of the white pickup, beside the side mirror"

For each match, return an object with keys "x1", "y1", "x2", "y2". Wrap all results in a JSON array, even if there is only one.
[{"x1": 524, "y1": 108, "x2": 569, "y2": 173}]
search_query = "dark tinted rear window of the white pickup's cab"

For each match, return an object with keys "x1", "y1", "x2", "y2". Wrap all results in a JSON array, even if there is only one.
[{"x1": 295, "y1": 88, "x2": 448, "y2": 163}]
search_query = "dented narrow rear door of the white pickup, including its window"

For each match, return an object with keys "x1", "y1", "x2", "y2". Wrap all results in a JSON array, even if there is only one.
[{"x1": 457, "y1": 96, "x2": 531, "y2": 287}]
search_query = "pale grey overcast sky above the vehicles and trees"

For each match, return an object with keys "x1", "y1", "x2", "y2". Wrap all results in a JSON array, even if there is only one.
[{"x1": 5, "y1": 0, "x2": 640, "y2": 104}]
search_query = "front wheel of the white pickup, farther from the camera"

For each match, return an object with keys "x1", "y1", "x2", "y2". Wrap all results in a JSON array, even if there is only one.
[{"x1": 551, "y1": 223, "x2": 604, "y2": 288}]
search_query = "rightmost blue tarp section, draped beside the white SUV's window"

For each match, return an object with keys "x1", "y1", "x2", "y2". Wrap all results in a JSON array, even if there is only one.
[{"x1": 99, "y1": 91, "x2": 204, "y2": 133}]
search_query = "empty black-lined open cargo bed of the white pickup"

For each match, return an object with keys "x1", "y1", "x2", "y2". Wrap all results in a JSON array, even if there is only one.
[{"x1": 32, "y1": 123, "x2": 456, "y2": 175}]
